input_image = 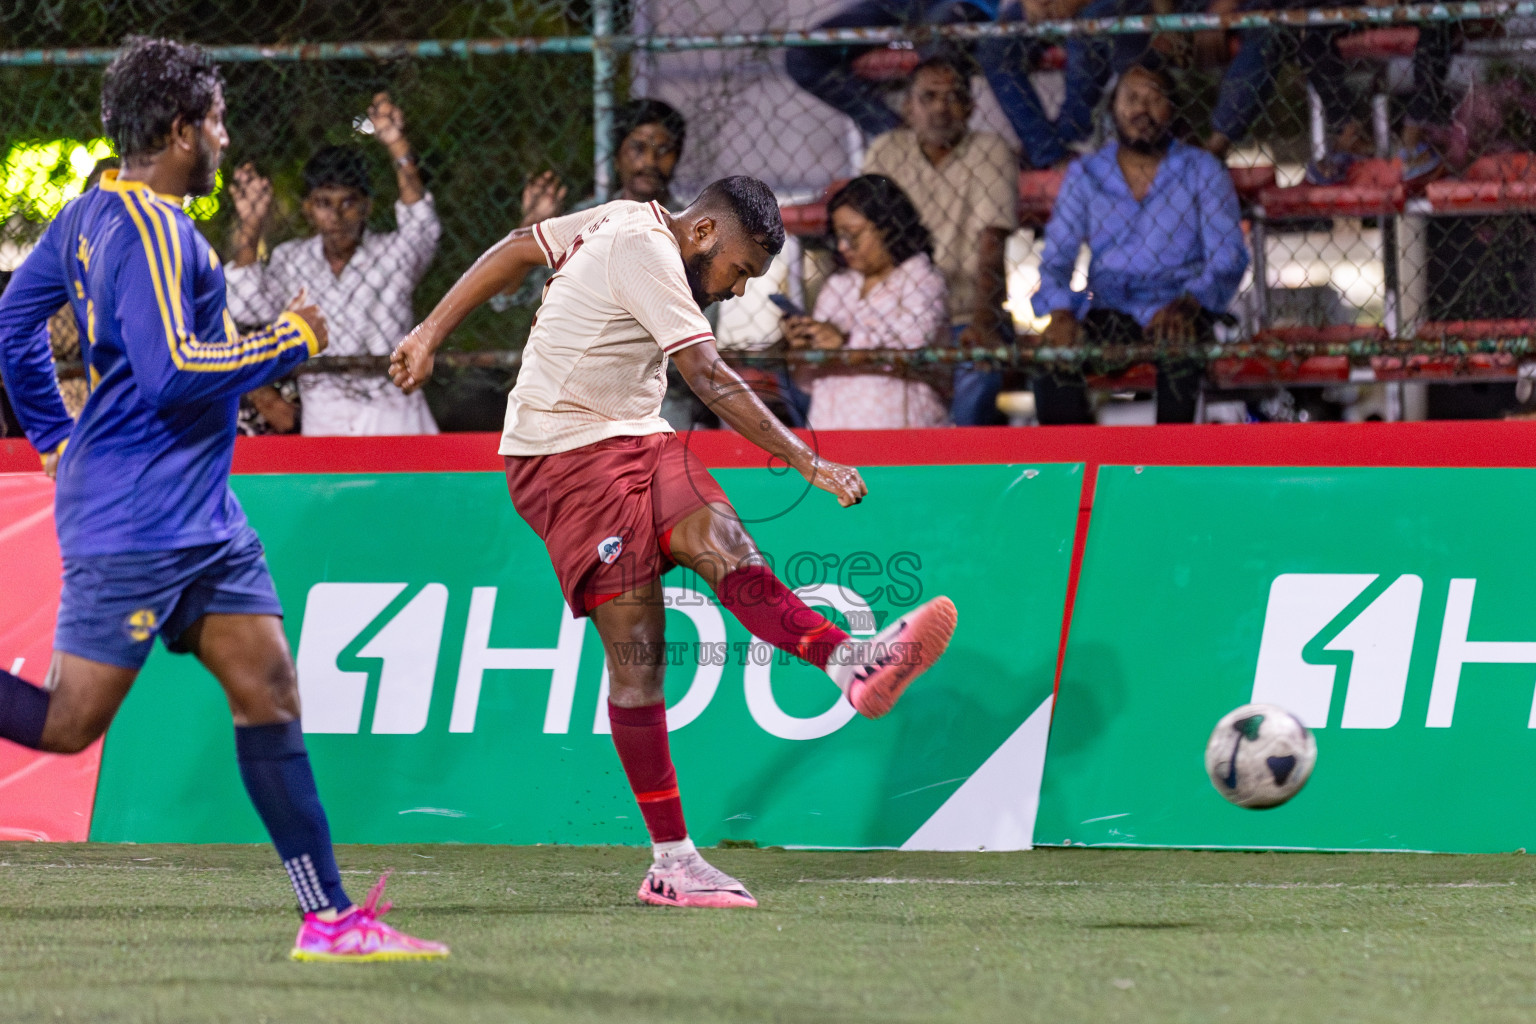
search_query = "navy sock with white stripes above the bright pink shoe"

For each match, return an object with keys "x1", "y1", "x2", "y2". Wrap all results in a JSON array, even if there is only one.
[{"x1": 235, "y1": 722, "x2": 352, "y2": 912}]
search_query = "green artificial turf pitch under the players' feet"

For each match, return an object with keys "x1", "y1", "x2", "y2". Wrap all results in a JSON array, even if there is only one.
[{"x1": 0, "y1": 843, "x2": 1536, "y2": 1024}]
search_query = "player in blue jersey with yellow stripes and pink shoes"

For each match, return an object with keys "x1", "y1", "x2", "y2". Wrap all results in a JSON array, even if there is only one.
[{"x1": 0, "y1": 38, "x2": 449, "y2": 960}]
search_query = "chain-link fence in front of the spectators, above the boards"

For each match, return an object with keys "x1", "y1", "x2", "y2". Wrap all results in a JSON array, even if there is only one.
[{"x1": 0, "y1": 0, "x2": 1536, "y2": 430}]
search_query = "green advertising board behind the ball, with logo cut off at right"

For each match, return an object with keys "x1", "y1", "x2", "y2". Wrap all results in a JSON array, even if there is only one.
[{"x1": 1035, "y1": 467, "x2": 1536, "y2": 852}]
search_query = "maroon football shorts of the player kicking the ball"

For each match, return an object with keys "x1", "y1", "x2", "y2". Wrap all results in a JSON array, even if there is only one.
[{"x1": 505, "y1": 431, "x2": 730, "y2": 616}]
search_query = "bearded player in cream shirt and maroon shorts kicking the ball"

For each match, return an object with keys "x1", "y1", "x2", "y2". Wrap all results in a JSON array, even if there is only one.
[{"x1": 390, "y1": 177, "x2": 955, "y2": 907}]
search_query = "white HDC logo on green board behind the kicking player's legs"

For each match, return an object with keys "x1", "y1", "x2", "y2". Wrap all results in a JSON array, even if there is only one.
[{"x1": 295, "y1": 583, "x2": 876, "y2": 740}]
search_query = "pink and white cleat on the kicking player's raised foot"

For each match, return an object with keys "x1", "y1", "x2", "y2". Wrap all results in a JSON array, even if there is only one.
[{"x1": 826, "y1": 597, "x2": 958, "y2": 718}]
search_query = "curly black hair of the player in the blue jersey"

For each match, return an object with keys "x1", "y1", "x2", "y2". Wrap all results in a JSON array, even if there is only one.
[{"x1": 101, "y1": 35, "x2": 224, "y2": 163}]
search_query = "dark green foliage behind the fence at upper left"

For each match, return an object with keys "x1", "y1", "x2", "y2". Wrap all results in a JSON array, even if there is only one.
[{"x1": 0, "y1": 0, "x2": 605, "y2": 363}]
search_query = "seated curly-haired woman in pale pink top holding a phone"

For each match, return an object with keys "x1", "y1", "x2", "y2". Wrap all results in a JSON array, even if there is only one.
[{"x1": 774, "y1": 175, "x2": 949, "y2": 430}]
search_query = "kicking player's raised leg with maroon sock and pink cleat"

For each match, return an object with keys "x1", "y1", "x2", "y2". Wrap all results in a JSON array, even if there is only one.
[{"x1": 662, "y1": 504, "x2": 957, "y2": 718}]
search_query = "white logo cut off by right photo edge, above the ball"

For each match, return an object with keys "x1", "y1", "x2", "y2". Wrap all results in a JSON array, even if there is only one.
[{"x1": 1253, "y1": 573, "x2": 1536, "y2": 729}]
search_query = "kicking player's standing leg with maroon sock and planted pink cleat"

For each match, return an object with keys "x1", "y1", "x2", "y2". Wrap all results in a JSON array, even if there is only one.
[{"x1": 591, "y1": 579, "x2": 757, "y2": 907}]
